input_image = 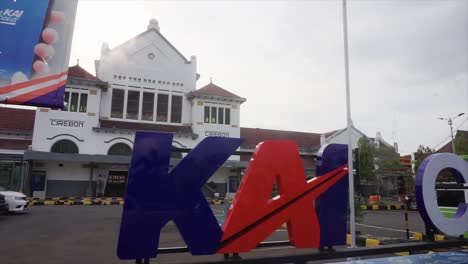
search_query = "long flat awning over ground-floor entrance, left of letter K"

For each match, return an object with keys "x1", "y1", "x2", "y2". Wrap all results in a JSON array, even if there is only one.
[{"x1": 24, "y1": 150, "x2": 132, "y2": 164}]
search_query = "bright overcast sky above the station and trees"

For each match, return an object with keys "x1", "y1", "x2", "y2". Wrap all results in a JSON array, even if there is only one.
[{"x1": 70, "y1": 0, "x2": 468, "y2": 154}]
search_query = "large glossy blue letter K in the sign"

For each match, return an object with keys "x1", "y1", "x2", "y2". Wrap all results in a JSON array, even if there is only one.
[{"x1": 117, "y1": 132, "x2": 242, "y2": 259}]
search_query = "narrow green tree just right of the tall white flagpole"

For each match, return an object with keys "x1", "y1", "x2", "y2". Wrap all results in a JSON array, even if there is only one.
[{"x1": 358, "y1": 136, "x2": 375, "y2": 183}]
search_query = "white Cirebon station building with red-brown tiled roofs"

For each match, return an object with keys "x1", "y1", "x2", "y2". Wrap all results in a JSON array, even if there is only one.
[{"x1": 0, "y1": 19, "x2": 392, "y2": 197}]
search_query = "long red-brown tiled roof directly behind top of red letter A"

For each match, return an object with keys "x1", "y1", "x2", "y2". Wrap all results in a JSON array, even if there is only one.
[{"x1": 240, "y1": 127, "x2": 320, "y2": 150}]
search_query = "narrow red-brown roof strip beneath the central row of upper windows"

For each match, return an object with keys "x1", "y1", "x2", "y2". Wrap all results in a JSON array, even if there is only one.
[{"x1": 100, "y1": 120, "x2": 193, "y2": 134}]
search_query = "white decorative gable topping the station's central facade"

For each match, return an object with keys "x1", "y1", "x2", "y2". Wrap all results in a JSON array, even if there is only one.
[{"x1": 96, "y1": 19, "x2": 197, "y2": 92}]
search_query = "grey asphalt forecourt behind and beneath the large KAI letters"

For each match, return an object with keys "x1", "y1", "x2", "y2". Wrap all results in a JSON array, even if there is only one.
[{"x1": 0, "y1": 206, "x2": 421, "y2": 264}]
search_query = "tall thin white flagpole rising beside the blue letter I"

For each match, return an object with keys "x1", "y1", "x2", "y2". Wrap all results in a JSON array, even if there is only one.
[{"x1": 343, "y1": 0, "x2": 356, "y2": 248}]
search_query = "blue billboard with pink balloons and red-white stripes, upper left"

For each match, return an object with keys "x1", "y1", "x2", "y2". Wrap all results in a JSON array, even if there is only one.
[{"x1": 0, "y1": 0, "x2": 78, "y2": 108}]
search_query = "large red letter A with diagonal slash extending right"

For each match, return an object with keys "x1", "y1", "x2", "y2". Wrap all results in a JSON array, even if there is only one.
[{"x1": 218, "y1": 141, "x2": 347, "y2": 253}]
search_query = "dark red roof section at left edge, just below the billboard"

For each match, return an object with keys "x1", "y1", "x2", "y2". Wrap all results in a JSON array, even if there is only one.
[{"x1": 0, "y1": 107, "x2": 36, "y2": 131}]
